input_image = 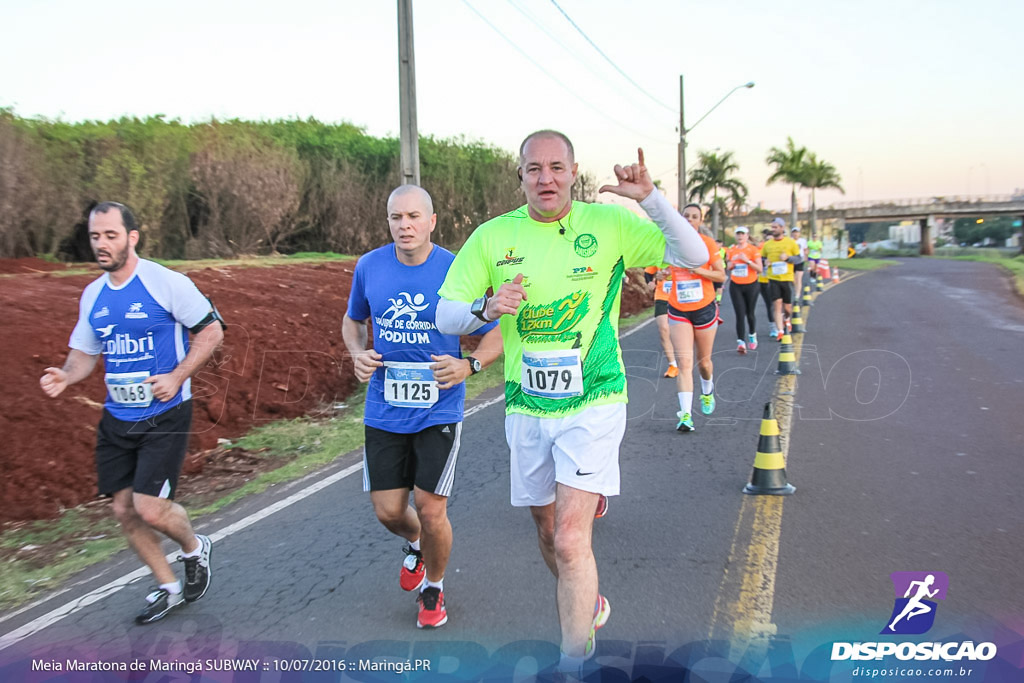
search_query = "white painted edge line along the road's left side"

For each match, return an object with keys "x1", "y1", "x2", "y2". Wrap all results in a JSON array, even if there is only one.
[{"x1": 0, "y1": 318, "x2": 654, "y2": 650}]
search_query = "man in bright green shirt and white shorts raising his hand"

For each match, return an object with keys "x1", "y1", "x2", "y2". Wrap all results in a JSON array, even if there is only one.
[{"x1": 436, "y1": 130, "x2": 709, "y2": 671}]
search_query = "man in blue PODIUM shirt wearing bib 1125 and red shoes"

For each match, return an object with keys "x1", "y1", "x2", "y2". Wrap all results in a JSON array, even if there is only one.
[{"x1": 341, "y1": 185, "x2": 502, "y2": 629}]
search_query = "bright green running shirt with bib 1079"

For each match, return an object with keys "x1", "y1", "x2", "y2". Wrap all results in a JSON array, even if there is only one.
[{"x1": 438, "y1": 202, "x2": 666, "y2": 418}]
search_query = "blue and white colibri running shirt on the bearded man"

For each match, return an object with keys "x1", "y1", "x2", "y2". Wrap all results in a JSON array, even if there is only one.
[{"x1": 68, "y1": 259, "x2": 211, "y2": 422}]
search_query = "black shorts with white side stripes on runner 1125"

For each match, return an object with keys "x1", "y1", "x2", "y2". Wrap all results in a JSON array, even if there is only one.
[{"x1": 362, "y1": 422, "x2": 462, "y2": 496}]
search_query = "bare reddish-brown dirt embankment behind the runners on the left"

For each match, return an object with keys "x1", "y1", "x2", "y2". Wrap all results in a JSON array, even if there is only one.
[{"x1": 0, "y1": 259, "x2": 650, "y2": 523}]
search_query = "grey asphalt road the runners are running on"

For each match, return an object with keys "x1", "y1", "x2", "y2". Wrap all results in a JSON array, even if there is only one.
[{"x1": 0, "y1": 259, "x2": 1024, "y2": 680}]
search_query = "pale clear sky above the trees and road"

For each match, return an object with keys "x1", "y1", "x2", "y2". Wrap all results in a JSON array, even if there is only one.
[{"x1": 0, "y1": 0, "x2": 1024, "y2": 209}]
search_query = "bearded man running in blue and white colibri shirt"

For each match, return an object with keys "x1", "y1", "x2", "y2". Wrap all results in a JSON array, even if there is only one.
[{"x1": 39, "y1": 202, "x2": 223, "y2": 624}]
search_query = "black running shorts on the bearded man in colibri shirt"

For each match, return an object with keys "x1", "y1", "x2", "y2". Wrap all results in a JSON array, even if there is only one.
[{"x1": 96, "y1": 400, "x2": 191, "y2": 500}]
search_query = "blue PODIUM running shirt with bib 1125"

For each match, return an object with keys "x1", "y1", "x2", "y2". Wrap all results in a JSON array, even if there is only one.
[{"x1": 348, "y1": 244, "x2": 496, "y2": 434}]
